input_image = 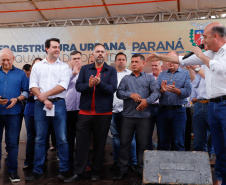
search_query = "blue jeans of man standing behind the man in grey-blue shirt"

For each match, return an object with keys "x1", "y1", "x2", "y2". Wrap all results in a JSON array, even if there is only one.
[{"x1": 110, "y1": 112, "x2": 137, "y2": 165}]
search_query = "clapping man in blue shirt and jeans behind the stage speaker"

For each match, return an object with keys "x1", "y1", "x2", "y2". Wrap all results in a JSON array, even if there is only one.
[{"x1": 157, "y1": 51, "x2": 191, "y2": 151}]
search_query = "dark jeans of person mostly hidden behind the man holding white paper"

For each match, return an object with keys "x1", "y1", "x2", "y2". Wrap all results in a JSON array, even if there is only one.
[{"x1": 24, "y1": 115, "x2": 36, "y2": 166}]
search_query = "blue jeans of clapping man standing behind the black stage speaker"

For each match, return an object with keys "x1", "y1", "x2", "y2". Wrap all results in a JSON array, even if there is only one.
[{"x1": 158, "y1": 107, "x2": 187, "y2": 151}]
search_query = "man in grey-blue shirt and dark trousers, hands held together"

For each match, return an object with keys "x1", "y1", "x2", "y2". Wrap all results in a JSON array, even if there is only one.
[{"x1": 114, "y1": 54, "x2": 160, "y2": 180}]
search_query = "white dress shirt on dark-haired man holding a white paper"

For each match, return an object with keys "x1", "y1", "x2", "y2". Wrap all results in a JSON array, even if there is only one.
[{"x1": 29, "y1": 59, "x2": 71, "y2": 99}]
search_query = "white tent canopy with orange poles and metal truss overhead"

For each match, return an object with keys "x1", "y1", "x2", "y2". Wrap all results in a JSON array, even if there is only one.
[{"x1": 0, "y1": 0, "x2": 226, "y2": 27}]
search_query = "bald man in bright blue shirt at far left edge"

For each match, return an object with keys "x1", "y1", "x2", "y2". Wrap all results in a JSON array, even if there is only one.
[{"x1": 0, "y1": 48, "x2": 29, "y2": 182}]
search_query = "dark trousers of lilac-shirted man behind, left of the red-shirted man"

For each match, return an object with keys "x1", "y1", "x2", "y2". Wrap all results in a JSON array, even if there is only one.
[{"x1": 67, "y1": 110, "x2": 79, "y2": 168}]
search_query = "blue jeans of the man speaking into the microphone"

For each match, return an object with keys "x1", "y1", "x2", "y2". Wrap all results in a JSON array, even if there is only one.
[{"x1": 209, "y1": 100, "x2": 226, "y2": 185}]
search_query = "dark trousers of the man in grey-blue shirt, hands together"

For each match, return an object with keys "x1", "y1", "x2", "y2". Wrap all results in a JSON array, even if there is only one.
[{"x1": 118, "y1": 116, "x2": 151, "y2": 173}]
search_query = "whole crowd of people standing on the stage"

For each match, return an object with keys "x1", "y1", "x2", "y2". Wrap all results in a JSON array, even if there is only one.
[{"x1": 0, "y1": 23, "x2": 226, "y2": 185}]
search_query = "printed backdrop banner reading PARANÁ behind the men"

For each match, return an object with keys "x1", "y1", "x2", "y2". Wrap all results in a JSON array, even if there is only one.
[{"x1": 0, "y1": 19, "x2": 226, "y2": 68}]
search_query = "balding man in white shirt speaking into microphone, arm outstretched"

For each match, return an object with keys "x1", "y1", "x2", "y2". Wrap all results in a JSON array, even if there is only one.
[{"x1": 148, "y1": 22, "x2": 226, "y2": 185}]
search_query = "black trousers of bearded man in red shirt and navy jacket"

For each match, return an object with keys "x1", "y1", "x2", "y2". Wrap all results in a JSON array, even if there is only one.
[{"x1": 74, "y1": 114, "x2": 112, "y2": 174}]
